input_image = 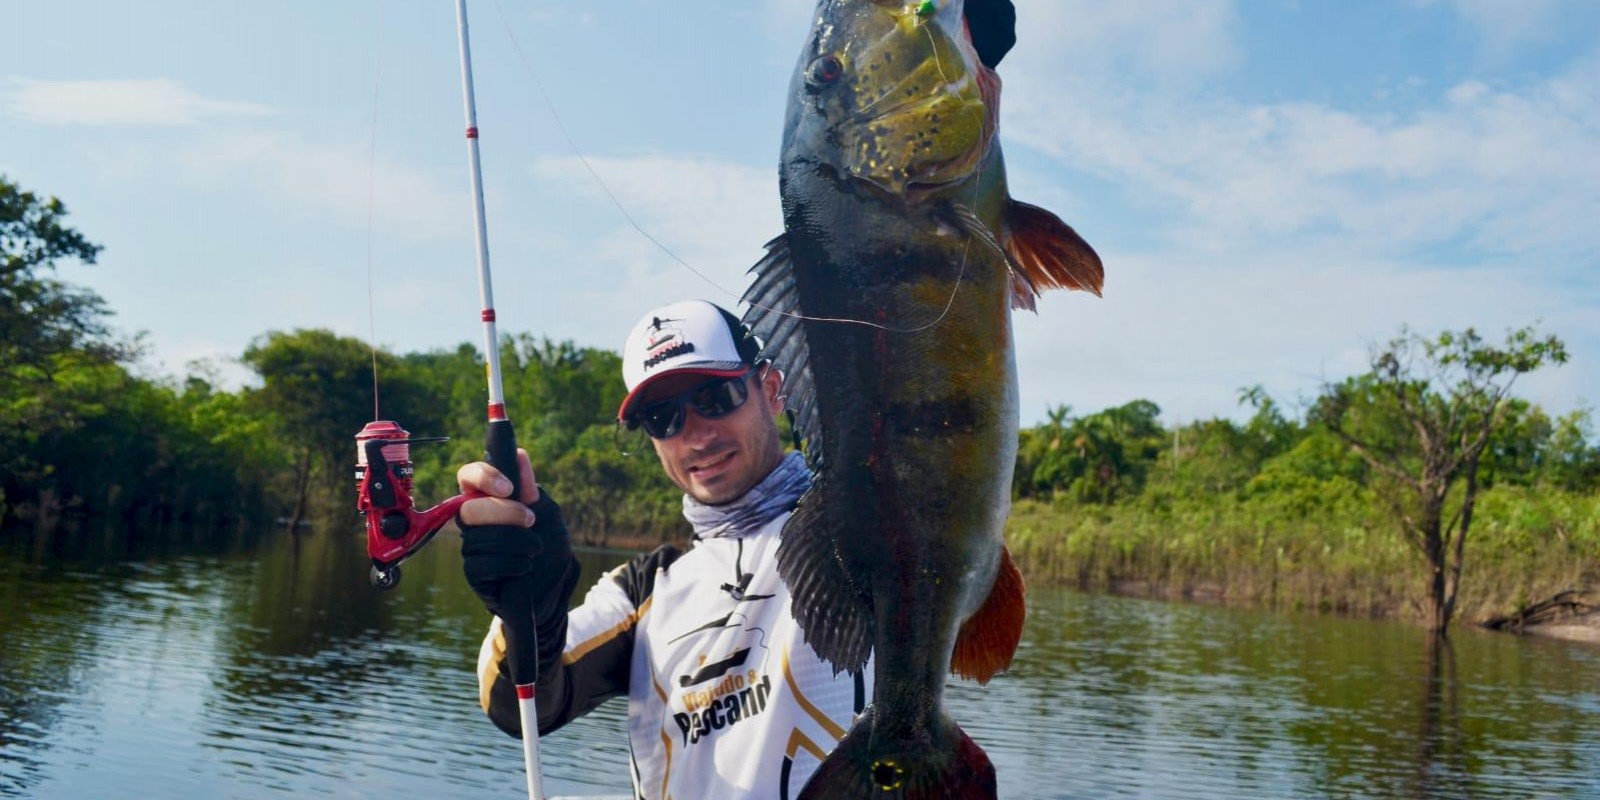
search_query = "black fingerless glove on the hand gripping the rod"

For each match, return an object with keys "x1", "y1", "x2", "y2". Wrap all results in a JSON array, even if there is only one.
[{"x1": 456, "y1": 486, "x2": 581, "y2": 674}]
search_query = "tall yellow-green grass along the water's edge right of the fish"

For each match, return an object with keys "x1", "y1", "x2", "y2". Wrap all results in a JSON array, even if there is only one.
[{"x1": 1006, "y1": 485, "x2": 1600, "y2": 622}]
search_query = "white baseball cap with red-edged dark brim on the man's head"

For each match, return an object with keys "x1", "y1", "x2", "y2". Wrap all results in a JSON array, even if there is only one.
[{"x1": 616, "y1": 299, "x2": 762, "y2": 419}]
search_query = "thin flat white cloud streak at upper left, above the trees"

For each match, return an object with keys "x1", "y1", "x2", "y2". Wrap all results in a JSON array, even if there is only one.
[{"x1": 0, "y1": 77, "x2": 272, "y2": 126}]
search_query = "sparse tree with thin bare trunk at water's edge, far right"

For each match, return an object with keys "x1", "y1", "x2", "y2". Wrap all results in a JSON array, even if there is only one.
[{"x1": 1312, "y1": 328, "x2": 1566, "y2": 635}]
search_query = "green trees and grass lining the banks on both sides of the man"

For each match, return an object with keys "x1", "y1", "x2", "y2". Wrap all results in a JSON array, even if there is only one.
[{"x1": 0, "y1": 178, "x2": 1600, "y2": 622}]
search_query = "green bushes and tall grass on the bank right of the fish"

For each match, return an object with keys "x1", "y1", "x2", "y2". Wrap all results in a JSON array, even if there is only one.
[{"x1": 1008, "y1": 378, "x2": 1600, "y2": 624}]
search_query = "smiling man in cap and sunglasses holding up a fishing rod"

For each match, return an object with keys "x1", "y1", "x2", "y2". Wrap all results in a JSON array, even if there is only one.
[{"x1": 458, "y1": 301, "x2": 872, "y2": 798}]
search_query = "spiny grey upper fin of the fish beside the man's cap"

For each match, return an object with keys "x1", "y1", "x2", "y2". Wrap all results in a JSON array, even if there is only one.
[{"x1": 739, "y1": 235, "x2": 822, "y2": 472}]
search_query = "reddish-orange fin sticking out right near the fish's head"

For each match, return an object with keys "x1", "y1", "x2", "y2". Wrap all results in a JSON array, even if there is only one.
[{"x1": 1005, "y1": 200, "x2": 1106, "y2": 309}]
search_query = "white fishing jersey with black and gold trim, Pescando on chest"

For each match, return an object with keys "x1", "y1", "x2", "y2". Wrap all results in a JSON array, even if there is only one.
[{"x1": 478, "y1": 514, "x2": 872, "y2": 800}]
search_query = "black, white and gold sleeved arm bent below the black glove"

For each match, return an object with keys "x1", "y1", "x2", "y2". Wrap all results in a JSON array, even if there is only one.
[{"x1": 478, "y1": 546, "x2": 680, "y2": 736}]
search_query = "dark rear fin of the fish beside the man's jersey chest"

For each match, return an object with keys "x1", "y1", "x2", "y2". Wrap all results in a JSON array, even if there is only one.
[{"x1": 778, "y1": 475, "x2": 875, "y2": 675}]
